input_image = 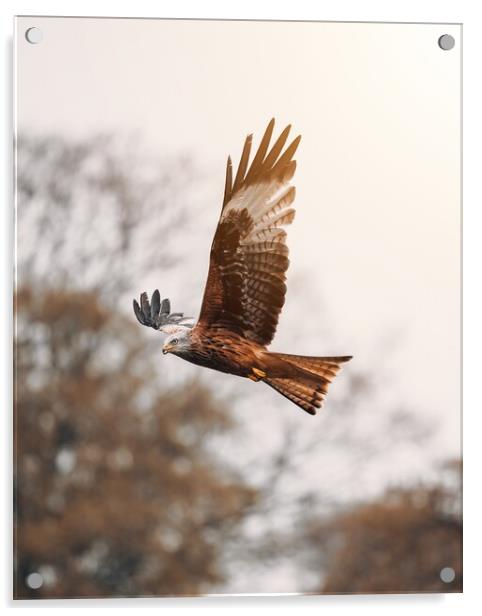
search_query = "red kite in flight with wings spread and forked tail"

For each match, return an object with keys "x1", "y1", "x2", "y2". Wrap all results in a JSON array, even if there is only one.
[{"x1": 134, "y1": 120, "x2": 351, "y2": 415}]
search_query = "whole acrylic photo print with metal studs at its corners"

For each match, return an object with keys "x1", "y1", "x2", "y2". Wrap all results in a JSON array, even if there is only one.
[{"x1": 14, "y1": 16, "x2": 462, "y2": 599}]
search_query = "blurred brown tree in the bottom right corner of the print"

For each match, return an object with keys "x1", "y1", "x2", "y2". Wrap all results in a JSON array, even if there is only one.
[{"x1": 301, "y1": 462, "x2": 462, "y2": 593}]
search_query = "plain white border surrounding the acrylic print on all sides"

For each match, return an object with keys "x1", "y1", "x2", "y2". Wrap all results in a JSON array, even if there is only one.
[{"x1": 0, "y1": 0, "x2": 482, "y2": 616}]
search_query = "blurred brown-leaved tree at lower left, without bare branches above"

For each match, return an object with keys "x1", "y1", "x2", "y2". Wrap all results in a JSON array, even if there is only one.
[{"x1": 15, "y1": 287, "x2": 255, "y2": 597}]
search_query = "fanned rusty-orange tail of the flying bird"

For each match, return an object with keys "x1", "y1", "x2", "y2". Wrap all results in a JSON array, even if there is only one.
[{"x1": 263, "y1": 353, "x2": 351, "y2": 415}]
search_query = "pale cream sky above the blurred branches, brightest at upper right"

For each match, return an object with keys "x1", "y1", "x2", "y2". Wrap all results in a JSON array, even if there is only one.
[{"x1": 16, "y1": 18, "x2": 461, "y2": 490}]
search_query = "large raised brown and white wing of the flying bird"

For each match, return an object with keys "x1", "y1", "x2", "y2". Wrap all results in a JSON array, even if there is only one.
[{"x1": 198, "y1": 120, "x2": 301, "y2": 345}]
